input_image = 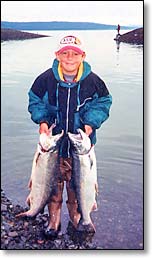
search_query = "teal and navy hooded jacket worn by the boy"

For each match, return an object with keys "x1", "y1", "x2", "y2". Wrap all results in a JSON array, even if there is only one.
[{"x1": 28, "y1": 59, "x2": 112, "y2": 157}]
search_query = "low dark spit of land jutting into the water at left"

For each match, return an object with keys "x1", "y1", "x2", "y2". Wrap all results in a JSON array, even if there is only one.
[{"x1": 1, "y1": 29, "x2": 49, "y2": 41}]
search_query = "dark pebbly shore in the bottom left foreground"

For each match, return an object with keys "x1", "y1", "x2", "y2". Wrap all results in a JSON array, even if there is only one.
[{"x1": 1, "y1": 190, "x2": 100, "y2": 250}]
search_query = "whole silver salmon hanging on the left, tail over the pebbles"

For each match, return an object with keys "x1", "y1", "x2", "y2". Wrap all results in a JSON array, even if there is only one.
[{"x1": 16, "y1": 124, "x2": 64, "y2": 218}]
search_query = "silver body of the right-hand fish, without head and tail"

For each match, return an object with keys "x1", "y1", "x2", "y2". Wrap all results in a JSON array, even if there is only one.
[{"x1": 73, "y1": 149, "x2": 97, "y2": 224}]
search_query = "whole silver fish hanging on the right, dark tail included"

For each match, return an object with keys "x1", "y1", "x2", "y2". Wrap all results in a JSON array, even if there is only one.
[{"x1": 68, "y1": 128, "x2": 98, "y2": 233}]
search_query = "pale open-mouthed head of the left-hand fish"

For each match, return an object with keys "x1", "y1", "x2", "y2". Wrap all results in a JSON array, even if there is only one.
[{"x1": 39, "y1": 130, "x2": 64, "y2": 152}]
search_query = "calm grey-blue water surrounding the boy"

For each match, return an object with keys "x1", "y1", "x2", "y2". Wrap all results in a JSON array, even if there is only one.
[{"x1": 1, "y1": 31, "x2": 143, "y2": 249}]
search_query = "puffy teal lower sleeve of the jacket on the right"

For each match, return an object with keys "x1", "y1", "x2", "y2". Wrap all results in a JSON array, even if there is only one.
[{"x1": 80, "y1": 93, "x2": 112, "y2": 129}]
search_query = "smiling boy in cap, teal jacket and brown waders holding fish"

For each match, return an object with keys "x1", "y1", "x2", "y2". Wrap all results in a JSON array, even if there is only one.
[{"x1": 28, "y1": 35, "x2": 112, "y2": 237}]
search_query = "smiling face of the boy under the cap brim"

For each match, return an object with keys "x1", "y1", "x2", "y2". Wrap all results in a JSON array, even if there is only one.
[{"x1": 56, "y1": 49, "x2": 85, "y2": 75}]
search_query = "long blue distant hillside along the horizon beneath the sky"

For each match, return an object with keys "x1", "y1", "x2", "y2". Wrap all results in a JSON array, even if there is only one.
[{"x1": 1, "y1": 21, "x2": 135, "y2": 30}]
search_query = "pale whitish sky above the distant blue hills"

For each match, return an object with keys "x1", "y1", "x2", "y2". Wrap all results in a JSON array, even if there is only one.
[{"x1": 1, "y1": 1, "x2": 143, "y2": 26}]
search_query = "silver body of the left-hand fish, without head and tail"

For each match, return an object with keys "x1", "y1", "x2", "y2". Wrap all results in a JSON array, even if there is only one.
[{"x1": 29, "y1": 152, "x2": 58, "y2": 216}]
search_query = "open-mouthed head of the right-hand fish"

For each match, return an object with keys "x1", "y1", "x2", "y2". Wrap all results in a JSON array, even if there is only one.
[{"x1": 68, "y1": 128, "x2": 91, "y2": 155}]
